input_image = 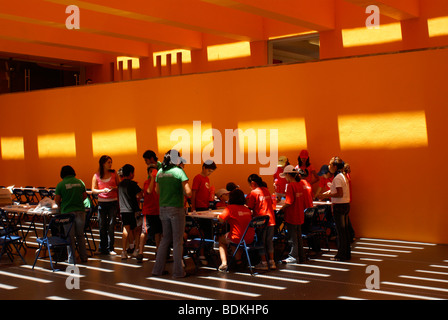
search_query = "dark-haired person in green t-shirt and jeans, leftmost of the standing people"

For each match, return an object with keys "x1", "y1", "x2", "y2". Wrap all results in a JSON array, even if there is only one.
[{"x1": 54, "y1": 166, "x2": 87, "y2": 263}]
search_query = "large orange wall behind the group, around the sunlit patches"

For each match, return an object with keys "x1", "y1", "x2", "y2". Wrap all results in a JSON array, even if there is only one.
[{"x1": 0, "y1": 49, "x2": 448, "y2": 243}]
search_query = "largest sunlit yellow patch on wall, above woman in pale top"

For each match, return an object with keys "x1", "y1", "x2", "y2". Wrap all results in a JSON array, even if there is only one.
[{"x1": 338, "y1": 111, "x2": 428, "y2": 150}]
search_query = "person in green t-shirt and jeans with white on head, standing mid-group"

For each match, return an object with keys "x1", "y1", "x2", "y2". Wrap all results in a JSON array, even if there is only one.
[{"x1": 152, "y1": 150, "x2": 191, "y2": 278}]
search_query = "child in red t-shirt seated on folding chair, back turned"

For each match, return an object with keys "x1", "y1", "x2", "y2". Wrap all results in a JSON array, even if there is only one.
[{"x1": 218, "y1": 189, "x2": 255, "y2": 272}]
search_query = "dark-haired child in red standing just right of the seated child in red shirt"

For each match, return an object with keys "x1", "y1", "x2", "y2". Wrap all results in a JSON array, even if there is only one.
[{"x1": 246, "y1": 174, "x2": 276, "y2": 270}]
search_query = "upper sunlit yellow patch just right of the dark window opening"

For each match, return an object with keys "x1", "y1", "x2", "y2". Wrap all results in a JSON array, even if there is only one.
[{"x1": 342, "y1": 22, "x2": 403, "y2": 47}]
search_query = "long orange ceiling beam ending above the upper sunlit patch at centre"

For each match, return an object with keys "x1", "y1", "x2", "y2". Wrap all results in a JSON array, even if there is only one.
[{"x1": 45, "y1": 0, "x2": 264, "y2": 41}]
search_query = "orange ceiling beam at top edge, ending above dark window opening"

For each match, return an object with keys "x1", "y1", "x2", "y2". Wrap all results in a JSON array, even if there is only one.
[{"x1": 202, "y1": 0, "x2": 335, "y2": 31}]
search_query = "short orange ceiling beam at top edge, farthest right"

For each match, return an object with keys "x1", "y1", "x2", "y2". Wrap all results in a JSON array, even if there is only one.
[{"x1": 345, "y1": 0, "x2": 425, "y2": 21}]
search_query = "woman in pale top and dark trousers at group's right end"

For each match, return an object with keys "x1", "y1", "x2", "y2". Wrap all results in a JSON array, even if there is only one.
[{"x1": 320, "y1": 157, "x2": 351, "y2": 261}]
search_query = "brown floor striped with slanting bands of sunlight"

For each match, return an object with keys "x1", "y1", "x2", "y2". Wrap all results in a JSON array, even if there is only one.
[{"x1": 0, "y1": 220, "x2": 448, "y2": 305}]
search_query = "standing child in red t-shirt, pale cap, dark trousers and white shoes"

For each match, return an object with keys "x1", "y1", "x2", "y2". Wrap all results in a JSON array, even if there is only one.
[{"x1": 280, "y1": 166, "x2": 313, "y2": 263}]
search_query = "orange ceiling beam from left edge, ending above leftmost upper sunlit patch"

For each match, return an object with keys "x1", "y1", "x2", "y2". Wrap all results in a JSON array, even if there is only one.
[{"x1": 0, "y1": 16, "x2": 149, "y2": 57}]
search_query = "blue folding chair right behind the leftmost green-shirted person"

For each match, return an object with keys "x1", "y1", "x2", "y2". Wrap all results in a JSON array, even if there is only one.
[{"x1": 33, "y1": 213, "x2": 75, "y2": 271}]
